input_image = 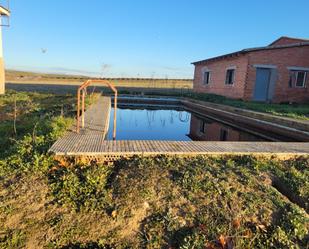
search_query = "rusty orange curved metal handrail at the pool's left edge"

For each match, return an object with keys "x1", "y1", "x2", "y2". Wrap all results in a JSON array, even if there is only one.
[{"x1": 76, "y1": 80, "x2": 118, "y2": 140}]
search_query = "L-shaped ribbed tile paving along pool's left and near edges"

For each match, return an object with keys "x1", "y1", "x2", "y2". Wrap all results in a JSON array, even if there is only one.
[{"x1": 50, "y1": 97, "x2": 309, "y2": 159}]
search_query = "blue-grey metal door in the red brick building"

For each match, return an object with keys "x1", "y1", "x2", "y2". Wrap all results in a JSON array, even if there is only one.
[{"x1": 253, "y1": 68, "x2": 271, "y2": 101}]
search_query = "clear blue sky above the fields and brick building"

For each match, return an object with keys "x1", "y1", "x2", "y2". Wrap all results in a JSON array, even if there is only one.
[{"x1": 0, "y1": 0, "x2": 309, "y2": 78}]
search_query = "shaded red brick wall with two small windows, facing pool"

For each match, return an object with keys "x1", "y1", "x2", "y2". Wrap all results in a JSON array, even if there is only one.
[{"x1": 193, "y1": 55, "x2": 248, "y2": 98}]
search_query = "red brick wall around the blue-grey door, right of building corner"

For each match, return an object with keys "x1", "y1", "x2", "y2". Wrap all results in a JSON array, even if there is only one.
[{"x1": 244, "y1": 46, "x2": 309, "y2": 103}]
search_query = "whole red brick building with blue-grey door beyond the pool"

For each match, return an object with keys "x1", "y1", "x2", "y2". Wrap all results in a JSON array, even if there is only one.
[{"x1": 192, "y1": 37, "x2": 309, "y2": 103}]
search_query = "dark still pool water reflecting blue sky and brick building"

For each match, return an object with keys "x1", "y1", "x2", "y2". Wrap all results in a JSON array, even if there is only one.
[{"x1": 107, "y1": 108, "x2": 263, "y2": 141}]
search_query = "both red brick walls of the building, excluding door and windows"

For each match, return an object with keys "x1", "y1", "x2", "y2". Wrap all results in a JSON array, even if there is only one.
[{"x1": 193, "y1": 46, "x2": 309, "y2": 103}]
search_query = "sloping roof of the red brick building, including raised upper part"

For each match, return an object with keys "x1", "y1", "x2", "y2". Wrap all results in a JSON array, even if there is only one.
[{"x1": 192, "y1": 36, "x2": 309, "y2": 65}]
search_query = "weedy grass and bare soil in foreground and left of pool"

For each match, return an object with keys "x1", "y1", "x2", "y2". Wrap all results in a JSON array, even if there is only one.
[{"x1": 0, "y1": 91, "x2": 309, "y2": 249}]
